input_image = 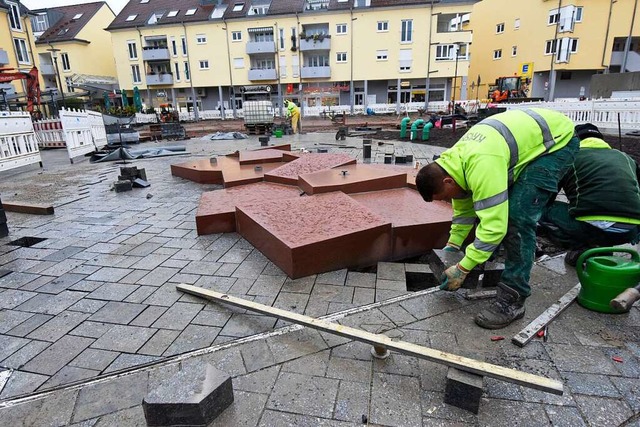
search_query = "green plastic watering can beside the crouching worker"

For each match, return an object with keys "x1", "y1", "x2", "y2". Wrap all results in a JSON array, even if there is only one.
[{"x1": 576, "y1": 248, "x2": 640, "y2": 313}]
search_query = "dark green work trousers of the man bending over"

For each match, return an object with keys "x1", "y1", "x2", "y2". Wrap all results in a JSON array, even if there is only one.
[{"x1": 500, "y1": 137, "x2": 580, "y2": 297}]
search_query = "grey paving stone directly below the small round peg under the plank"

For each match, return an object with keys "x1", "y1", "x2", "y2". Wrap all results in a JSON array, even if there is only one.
[{"x1": 369, "y1": 373, "x2": 422, "y2": 426}]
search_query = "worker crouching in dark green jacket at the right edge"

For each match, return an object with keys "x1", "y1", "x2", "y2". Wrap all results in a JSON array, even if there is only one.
[{"x1": 539, "y1": 123, "x2": 640, "y2": 267}]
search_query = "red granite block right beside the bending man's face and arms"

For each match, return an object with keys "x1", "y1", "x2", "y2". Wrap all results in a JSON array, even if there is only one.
[{"x1": 351, "y1": 188, "x2": 453, "y2": 260}]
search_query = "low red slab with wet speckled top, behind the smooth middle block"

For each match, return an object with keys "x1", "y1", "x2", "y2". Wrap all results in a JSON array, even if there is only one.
[{"x1": 264, "y1": 153, "x2": 356, "y2": 185}]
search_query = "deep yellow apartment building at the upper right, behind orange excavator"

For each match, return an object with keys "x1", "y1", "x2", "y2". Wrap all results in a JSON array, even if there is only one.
[{"x1": 469, "y1": 0, "x2": 640, "y2": 100}]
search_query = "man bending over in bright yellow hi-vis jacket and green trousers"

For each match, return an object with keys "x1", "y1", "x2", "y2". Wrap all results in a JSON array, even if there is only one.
[{"x1": 416, "y1": 108, "x2": 579, "y2": 329}]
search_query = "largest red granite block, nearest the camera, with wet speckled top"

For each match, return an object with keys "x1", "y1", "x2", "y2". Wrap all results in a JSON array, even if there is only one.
[{"x1": 236, "y1": 192, "x2": 391, "y2": 279}]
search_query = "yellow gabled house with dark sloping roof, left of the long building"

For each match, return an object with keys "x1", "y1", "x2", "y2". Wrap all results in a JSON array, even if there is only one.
[{"x1": 31, "y1": 1, "x2": 117, "y2": 107}]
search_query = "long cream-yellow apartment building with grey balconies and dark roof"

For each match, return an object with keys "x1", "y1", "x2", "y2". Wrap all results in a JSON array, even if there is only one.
[{"x1": 108, "y1": 0, "x2": 476, "y2": 115}]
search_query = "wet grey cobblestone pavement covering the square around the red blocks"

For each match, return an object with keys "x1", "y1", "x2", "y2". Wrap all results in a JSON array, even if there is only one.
[{"x1": 0, "y1": 134, "x2": 640, "y2": 426}]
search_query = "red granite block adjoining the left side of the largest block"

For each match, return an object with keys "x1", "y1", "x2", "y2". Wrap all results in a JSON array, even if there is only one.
[{"x1": 196, "y1": 182, "x2": 300, "y2": 235}]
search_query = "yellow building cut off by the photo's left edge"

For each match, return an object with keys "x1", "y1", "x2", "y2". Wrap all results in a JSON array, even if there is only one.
[{"x1": 0, "y1": 0, "x2": 36, "y2": 108}]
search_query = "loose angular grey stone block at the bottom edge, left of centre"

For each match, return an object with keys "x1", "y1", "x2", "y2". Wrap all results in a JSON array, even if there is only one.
[{"x1": 142, "y1": 364, "x2": 233, "y2": 426}]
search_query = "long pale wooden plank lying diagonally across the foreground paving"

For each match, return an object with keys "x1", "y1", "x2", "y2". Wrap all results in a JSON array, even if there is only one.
[{"x1": 176, "y1": 284, "x2": 563, "y2": 395}]
